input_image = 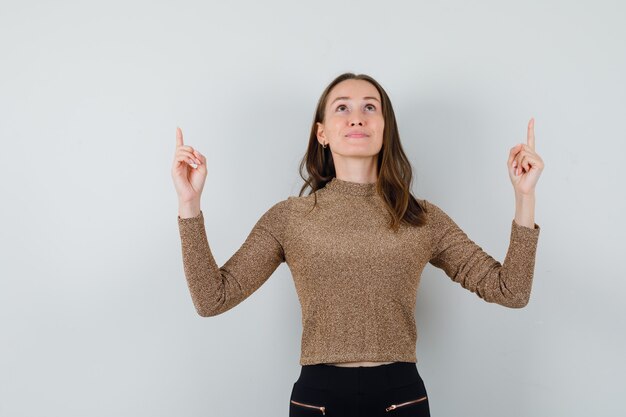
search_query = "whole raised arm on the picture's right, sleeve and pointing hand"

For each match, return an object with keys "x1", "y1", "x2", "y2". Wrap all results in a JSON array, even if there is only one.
[{"x1": 424, "y1": 118, "x2": 544, "y2": 308}]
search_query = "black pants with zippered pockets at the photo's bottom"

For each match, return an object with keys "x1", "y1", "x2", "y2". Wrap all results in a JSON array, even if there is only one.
[{"x1": 289, "y1": 362, "x2": 430, "y2": 417}]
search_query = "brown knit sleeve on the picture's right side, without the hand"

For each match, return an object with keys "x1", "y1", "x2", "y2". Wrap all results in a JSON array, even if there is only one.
[{"x1": 424, "y1": 200, "x2": 540, "y2": 308}]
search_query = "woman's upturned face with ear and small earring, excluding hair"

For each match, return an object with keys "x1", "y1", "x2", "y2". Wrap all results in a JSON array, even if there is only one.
[{"x1": 317, "y1": 80, "x2": 385, "y2": 157}]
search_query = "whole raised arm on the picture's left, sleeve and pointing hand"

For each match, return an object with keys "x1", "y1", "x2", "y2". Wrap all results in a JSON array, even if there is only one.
[{"x1": 172, "y1": 128, "x2": 288, "y2": 317}]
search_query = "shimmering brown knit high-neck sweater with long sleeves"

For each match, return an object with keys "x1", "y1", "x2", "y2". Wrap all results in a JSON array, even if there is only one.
[{"x1": 178, "y1": 178, "x2": 540, "y2": 365}]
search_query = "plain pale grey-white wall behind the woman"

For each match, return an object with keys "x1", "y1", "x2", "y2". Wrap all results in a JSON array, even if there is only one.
[{"x1": 0, "y1": 0, "x2": 626, "y2": 417}]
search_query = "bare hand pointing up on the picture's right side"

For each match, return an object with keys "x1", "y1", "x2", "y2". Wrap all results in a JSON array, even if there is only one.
[{"x1": 507, "y1": 118, "x2": 543, "y2": 195}]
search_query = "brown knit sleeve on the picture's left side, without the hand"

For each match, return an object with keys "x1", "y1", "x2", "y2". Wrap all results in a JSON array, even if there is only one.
[{"x1": 178, "y1": 200, "x2": 287, "y2": 317}]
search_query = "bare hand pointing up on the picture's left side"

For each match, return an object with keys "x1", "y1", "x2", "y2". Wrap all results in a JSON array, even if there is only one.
[{"x1": 172, "y1": 127, "x2": 207, "y2": 203}]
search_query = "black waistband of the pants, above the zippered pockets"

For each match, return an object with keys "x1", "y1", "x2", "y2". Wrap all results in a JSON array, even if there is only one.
[{"x1": 296, "y1": 362, "x2": 421, "y2": 393}]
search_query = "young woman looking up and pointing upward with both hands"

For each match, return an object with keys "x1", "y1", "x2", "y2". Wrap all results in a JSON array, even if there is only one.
[{"x1": 172, "y1": 73, "x2": 544, "y2": 417}]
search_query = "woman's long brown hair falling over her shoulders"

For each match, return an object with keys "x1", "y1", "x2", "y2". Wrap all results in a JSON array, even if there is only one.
[{"x1": 299, "y1": 72, "x2": 426, "y2": 231}]
